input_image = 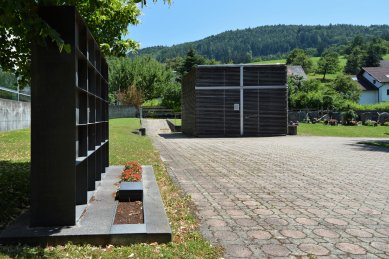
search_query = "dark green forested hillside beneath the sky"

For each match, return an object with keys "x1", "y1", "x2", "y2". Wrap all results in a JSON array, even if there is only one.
[{"x1": 138, "y1": 25, "x2": 389, "y2": 63}]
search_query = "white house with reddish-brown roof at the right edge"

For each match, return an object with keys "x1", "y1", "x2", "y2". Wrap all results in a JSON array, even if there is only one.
[{"x1": 353, "y1": 67, "x2": 389, "y2": 104}]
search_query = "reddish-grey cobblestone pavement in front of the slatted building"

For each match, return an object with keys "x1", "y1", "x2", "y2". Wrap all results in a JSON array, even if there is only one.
[{"x1": 142, "y1": 121, "x2": 389, "y2": 258}]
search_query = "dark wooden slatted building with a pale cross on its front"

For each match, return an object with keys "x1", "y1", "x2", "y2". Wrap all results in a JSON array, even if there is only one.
[{"x1": 182, "y1": 65, "x2": 288, "y2": 137}]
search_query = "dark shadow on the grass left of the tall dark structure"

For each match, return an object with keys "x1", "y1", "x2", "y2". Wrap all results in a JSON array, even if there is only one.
[{"x1": 0, "y1": 161, "x2": 30, "y2": 230}]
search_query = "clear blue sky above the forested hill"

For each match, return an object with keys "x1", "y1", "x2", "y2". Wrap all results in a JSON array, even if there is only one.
[{"x1": 127, "y1": 0, "x2": 389, "y2": 48}]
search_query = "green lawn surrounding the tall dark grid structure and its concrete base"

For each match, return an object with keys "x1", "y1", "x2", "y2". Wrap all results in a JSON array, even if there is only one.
[{"x1": 0, "y1": 119, "x2": 222, "y2": 258}]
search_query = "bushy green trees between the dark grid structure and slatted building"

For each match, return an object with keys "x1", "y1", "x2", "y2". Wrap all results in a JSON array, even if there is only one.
[{"x1": 108, "y1": 56, "x2": 181, "y2": 111}]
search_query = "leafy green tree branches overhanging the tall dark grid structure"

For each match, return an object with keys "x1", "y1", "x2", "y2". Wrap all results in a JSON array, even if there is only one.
[{"x1": 0, "y1": 0, "x2": 170, "y2": 84}]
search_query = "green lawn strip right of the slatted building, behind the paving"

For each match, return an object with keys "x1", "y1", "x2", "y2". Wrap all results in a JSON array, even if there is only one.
[{"x1": 297, "y1": 123, "x2": 389, "y2": 138}]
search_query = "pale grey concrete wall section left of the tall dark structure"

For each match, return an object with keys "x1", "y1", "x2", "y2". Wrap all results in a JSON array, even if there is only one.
[{"x1": 0, "y1": 99, "x2": 31, "y2": 131}]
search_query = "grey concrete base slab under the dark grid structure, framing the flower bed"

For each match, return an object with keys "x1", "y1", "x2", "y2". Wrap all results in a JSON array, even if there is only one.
[{"x1": 0, "y1": 166, "x2": 172, "y2": 246}]
